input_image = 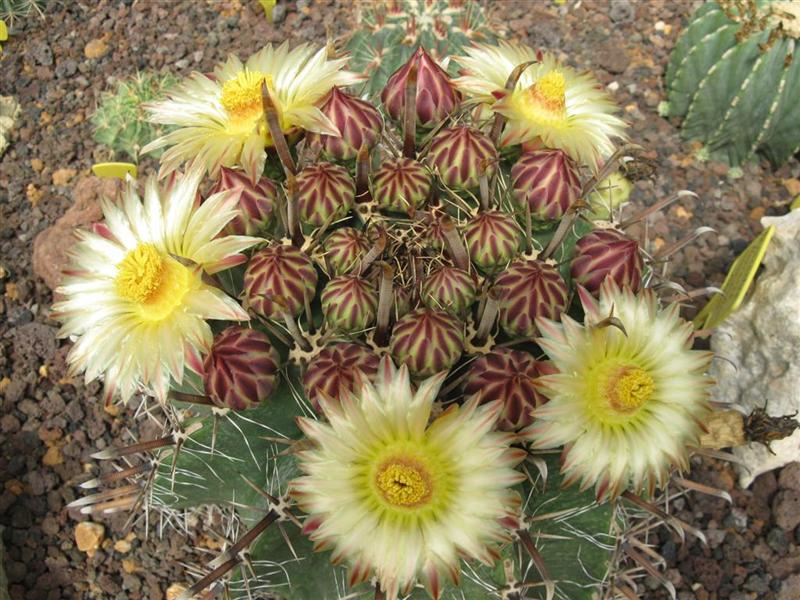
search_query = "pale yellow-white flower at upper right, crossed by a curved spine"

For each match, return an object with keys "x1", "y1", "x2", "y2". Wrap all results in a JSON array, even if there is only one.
[{"x1": 454, "y1": 41, "x2": 626, "y2": 170}]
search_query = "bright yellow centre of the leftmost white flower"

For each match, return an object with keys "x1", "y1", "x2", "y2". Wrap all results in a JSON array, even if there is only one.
[{"x1": 114, "y1": 244, "x2": 190, "y2": 321}]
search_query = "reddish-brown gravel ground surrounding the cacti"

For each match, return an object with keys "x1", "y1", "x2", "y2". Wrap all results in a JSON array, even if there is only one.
[{"x1": 0, "y1": 0, "x2": 800, "y2": 600}]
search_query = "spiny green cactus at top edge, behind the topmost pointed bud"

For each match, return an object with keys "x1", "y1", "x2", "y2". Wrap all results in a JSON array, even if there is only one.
[{"x1": 346, "y1": 0, "x2": 502, "y2": 95}]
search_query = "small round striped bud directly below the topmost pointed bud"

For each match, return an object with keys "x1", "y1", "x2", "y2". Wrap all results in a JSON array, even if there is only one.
[{"x1": 372, "y1": 158, "x2": 431, "y2": 213}]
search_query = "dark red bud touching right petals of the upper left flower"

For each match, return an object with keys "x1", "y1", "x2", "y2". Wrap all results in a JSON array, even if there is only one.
[{"x1": 307, "y1": 88, "x2": 383, "y2": 160}]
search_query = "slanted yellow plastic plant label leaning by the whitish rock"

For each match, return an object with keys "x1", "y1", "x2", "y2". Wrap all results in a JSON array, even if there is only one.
[{"x1": 694, "y1": 225, "x2": 775, "y2": 329}]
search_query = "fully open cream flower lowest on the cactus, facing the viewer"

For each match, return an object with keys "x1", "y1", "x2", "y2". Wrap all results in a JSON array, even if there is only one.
[{"x1": 290, "y1": 358, "x2": 525, "y2": 600}]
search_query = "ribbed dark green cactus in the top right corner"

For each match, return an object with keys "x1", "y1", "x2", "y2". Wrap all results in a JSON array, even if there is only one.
[{"x1": 665, "y1": 2, "x2": 800, "y2": 168}]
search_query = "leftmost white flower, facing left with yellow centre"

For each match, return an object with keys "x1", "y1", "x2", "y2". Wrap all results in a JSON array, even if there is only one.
[{"x1": 53, "y1": 172, "x2": 261, "y2": 402}]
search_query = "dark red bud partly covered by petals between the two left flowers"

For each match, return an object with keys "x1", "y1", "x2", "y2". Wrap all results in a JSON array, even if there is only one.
[{"x1": 209, "y1": 167, "x2": 277, "y2": 235}]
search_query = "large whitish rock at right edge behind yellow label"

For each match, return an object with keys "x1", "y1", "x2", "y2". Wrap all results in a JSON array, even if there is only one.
[{"x1": 711, "y1": 210, "x2": 800, "y2": 487}]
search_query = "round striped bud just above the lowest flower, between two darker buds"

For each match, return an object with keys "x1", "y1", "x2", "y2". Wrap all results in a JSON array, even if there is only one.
[{"x1": 389, "y1": 308, "x2": 464, "y2": 377}]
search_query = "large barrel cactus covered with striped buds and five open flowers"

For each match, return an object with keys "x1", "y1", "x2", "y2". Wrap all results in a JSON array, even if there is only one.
[{"x1": 59, "y1": 30, "x2": 728, "y2": 600}]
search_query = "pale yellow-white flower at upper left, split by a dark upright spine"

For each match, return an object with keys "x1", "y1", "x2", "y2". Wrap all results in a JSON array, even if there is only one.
[{"x1": 142, "y1": 43, "x2": 362, "y2": 182}]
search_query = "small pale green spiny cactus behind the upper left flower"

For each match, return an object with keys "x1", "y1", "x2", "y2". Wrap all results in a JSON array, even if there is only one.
[{"x1": 92, "y1": 72, "x2": 178, "y2": 162}]
